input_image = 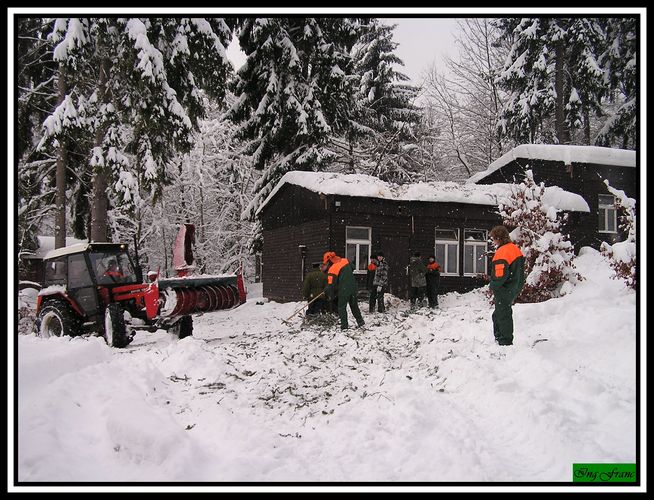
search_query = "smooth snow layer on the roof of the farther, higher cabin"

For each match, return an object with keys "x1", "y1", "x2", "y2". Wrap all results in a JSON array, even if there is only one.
[{"x1": 466, "y1": 144, "x2": 636, "y2": 184}]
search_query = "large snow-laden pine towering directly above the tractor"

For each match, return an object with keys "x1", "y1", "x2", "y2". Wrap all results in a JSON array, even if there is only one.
[{"x1": 37, "y1": 18, "x2": 231, "y2": 244}]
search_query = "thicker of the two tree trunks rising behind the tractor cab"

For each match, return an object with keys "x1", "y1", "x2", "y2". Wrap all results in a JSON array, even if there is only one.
[{"x1": 91, "y1": 58, "x2": 109, "y2": 241}]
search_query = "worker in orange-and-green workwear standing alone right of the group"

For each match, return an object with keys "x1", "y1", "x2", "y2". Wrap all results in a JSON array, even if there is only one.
[{"x1": 490, "y1": 226, "x2": 525, "y2": 345}]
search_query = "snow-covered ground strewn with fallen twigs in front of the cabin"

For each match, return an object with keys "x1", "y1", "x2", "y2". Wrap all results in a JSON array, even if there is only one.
[{"x1": 14, "y1": 249, "x2": 644, "y2": 491}]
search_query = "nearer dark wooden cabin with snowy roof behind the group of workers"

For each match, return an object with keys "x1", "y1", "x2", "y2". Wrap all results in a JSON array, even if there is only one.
[{"x1": 257, "y1": 172, "x2": 588, "y2": 302}]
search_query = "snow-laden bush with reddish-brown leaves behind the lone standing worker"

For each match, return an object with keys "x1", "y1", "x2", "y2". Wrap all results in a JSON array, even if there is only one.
[{"x1": 499, "y1": 170, "x2": 583, "y2": 302}]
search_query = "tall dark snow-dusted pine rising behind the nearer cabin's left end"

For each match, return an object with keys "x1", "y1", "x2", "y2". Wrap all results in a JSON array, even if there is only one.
[{"x1": 227, "y1": 18, "x2": 364, "y2": 251}]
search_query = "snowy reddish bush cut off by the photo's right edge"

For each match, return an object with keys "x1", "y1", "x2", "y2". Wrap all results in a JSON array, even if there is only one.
[{"x1": 600, "y1": 180, "x2": 637, "y2": 289}]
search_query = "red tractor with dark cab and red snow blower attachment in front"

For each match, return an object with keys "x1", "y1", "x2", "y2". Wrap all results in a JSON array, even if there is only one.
[{"x1": 36, "y1": 229, "x2": 246, "y2": 347}]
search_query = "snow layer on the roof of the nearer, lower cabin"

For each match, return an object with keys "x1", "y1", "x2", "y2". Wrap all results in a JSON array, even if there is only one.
[{"x1": 257, "y1": 171, "x2": 590, "y2": 214}]
